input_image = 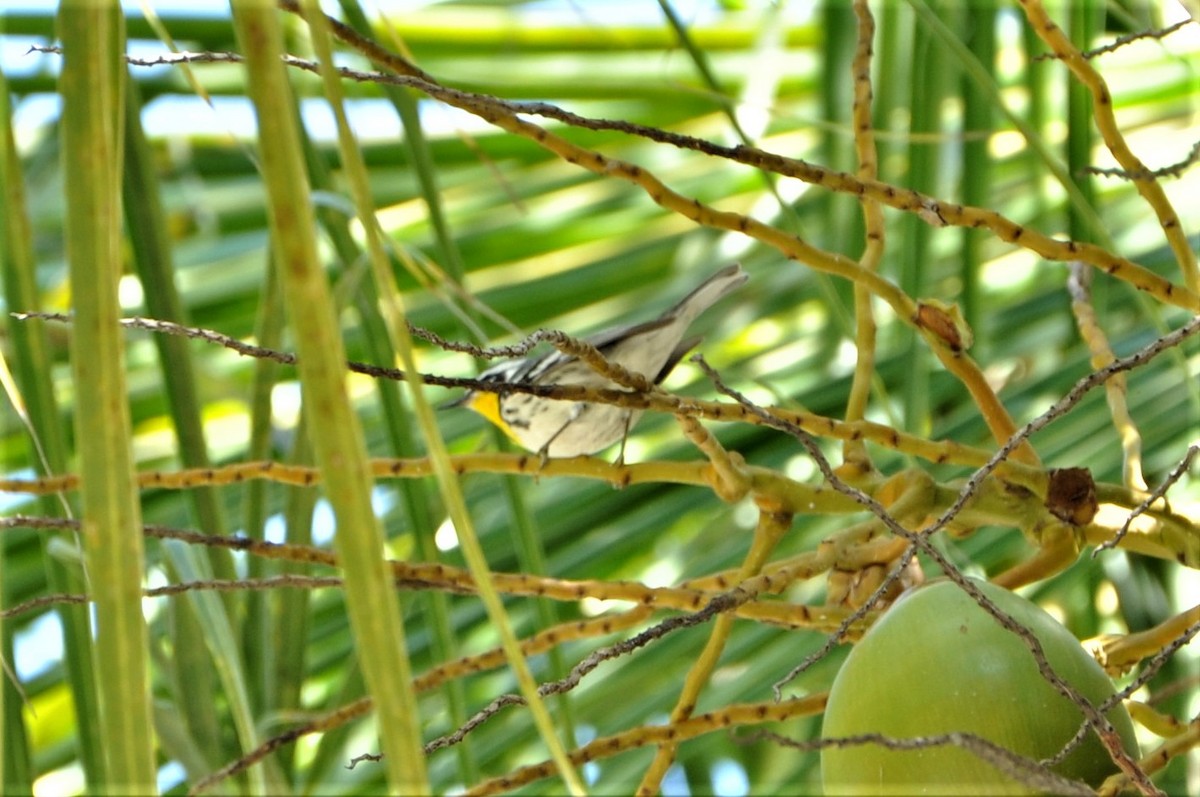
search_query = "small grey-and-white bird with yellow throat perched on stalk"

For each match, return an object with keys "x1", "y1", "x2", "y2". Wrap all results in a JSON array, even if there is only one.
[{"x1": 450, "y1": 264, "x2": 748, "y2": 461}]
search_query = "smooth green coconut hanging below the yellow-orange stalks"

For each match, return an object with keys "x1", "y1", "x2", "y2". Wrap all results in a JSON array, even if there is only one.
[{"x1": 821, "y1": 580, "x2": 1138, "y2": 795}]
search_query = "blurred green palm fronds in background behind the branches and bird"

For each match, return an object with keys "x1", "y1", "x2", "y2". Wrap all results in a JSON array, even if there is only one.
[{"x1": 0, "y1": 0, "x2": 1200, "y2": 795}]
